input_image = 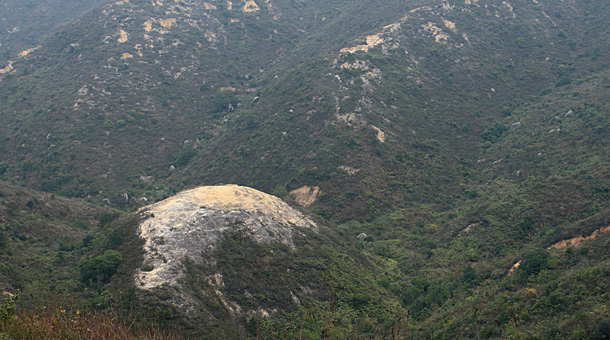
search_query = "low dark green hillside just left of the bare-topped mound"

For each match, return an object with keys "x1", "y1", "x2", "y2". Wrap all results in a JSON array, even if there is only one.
[{"x1": 0, "y1": 182, "x2": 114, "y2": 298}]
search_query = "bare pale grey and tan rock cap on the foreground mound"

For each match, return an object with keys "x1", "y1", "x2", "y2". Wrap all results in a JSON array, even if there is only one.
[{"x1": 135, "y1": 185, "x2": 318, "y2": 290}]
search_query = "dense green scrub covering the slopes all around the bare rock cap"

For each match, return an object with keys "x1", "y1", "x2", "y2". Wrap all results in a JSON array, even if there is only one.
[{"x1": 0, "y1": 0, "x2": 610, "y2": 339}]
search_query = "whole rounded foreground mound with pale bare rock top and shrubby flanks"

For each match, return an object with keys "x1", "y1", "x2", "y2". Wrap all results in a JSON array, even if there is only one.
[{"x1": 96, "y1": 185, "x2": 404, "y2": 339}]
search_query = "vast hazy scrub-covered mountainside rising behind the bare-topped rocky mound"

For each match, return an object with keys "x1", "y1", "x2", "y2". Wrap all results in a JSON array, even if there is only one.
[{"x1": 0, "y1": 0, "x2": 610, "y2": 338}]
